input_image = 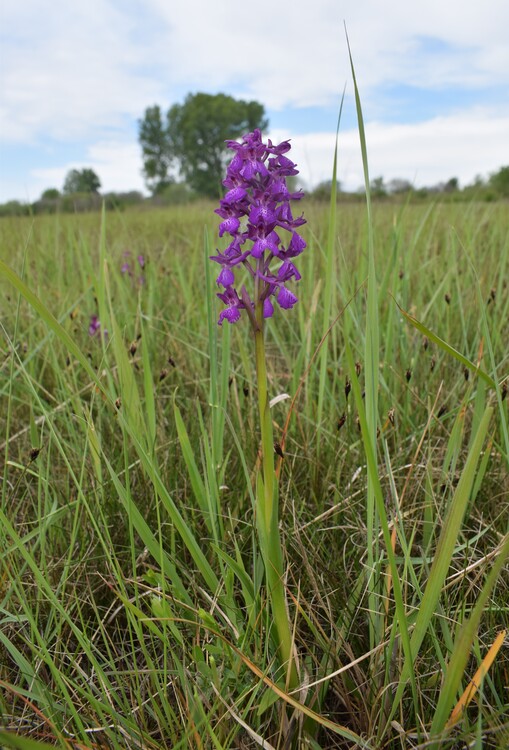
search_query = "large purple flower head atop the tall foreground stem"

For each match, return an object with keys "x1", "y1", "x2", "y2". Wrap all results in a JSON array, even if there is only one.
[{"x1": 211, "y1": 130, "x2": 306, "y2": 325}]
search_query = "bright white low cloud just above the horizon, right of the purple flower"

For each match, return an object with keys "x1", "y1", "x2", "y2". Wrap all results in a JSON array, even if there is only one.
[{"x1": 273, "y1": 110, "x2": 509, "y2": 190}]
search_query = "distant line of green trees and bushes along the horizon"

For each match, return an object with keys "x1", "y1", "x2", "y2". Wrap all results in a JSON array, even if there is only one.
[{"x1": 0, "y1": 93, "x2": 509, "y2": 216}]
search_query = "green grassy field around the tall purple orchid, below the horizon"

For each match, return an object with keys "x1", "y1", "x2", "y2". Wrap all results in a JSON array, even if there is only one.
[{"x1": 0, "y1": 201, "x2": 509, "y2": 750}]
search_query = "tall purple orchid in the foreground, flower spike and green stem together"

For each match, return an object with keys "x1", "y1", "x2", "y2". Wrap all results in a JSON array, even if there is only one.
[{"x1": 211, "y1": 130, "x2": 306, "y2": 689}]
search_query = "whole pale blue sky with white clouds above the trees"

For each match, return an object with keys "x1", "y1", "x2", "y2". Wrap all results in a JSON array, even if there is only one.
[{"x1": 0, "y1": 0, "x2": 509, "y2": 203}]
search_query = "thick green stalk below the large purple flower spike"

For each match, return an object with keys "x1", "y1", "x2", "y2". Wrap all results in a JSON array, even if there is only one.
[{"x1": 255, "y1": 302, "x2": 298, "y2": 690}]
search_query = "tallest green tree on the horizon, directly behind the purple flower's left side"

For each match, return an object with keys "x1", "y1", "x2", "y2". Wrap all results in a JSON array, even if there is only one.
[{"x1": 139, "y1": 93, "x2": 268, "y2": 197}]
